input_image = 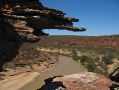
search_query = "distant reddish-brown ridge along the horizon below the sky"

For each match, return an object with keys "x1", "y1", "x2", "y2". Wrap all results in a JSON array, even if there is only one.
[{"x1": 39, "y1": 35, "x2": 119, "y2": 50}]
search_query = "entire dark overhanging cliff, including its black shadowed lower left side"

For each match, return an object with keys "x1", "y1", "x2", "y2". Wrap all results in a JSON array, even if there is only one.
[{"x1": 0, "y1": 0, "x2": 85, "y2": 70}]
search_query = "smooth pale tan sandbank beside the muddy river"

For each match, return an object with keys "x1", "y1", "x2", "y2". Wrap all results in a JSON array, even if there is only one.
[{"x1": 0, "y1": 72, "x2": 40, "y2": 90}]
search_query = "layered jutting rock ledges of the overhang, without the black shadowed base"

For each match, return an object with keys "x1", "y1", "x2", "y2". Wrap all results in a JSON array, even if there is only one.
[{"x1": 0, "y1": 0, "x2": 86, "y2": 40}]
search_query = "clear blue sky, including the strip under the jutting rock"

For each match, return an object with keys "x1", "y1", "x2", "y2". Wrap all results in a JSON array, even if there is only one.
[{"x1": 42, "y1": 0, "x2": 119, "y2": 36}]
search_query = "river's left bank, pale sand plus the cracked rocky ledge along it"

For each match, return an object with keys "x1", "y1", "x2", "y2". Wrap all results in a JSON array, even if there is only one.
[{"x1": 0, "y1": 56, "x2": 58, "y2": 90}]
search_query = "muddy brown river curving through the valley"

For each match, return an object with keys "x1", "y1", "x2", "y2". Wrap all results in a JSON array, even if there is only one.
[{"x1": 22, "y1": 56, "x2": 86, "y2": 90}]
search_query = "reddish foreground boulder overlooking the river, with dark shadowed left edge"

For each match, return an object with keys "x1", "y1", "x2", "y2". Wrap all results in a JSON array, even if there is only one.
[{"x1": 39, "y1": 72, "x2": 119, "y2": 90}]
